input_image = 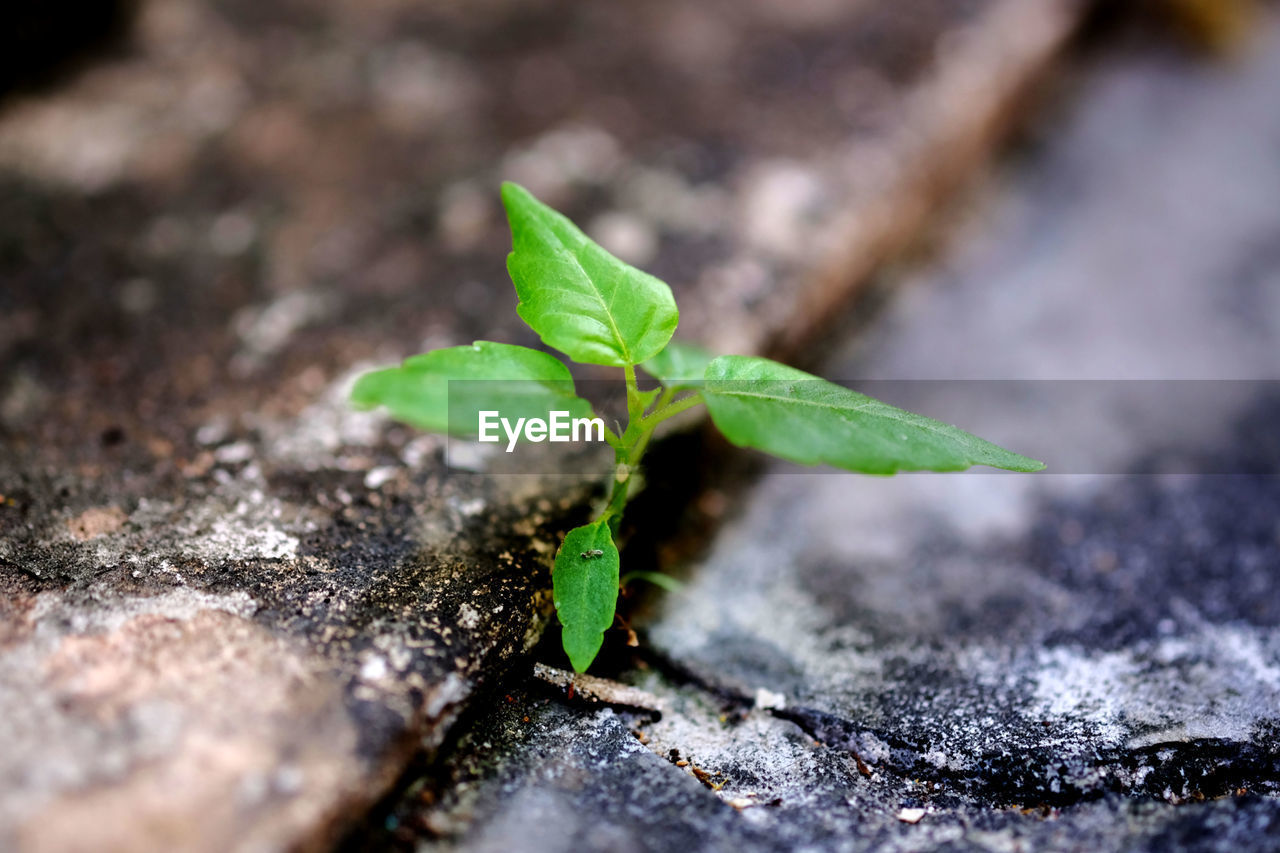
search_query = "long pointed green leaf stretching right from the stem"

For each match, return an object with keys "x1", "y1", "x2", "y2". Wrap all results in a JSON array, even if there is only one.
[{"x1": 703, "y1": 356, "x2": 1044, "y2": 474}]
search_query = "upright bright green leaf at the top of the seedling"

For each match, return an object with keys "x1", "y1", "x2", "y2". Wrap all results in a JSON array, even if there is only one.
[{"x1": 502, "y1": 182, "x2": 680, "y2": 366}]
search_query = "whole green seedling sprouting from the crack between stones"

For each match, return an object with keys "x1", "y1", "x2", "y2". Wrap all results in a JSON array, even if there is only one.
[{"x1": 352, "y1": 183, "x2": 1044, "y2": 672}]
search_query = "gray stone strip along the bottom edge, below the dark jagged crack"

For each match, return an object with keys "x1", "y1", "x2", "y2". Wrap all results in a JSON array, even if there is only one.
[{"x1": 351, "y1": 690, "x2": 1280, "y2": 853}]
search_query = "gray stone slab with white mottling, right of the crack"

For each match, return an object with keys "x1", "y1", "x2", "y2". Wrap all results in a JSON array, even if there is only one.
[{"x1": 374, "y1": 13, "x2": 1280, "y2": 850}]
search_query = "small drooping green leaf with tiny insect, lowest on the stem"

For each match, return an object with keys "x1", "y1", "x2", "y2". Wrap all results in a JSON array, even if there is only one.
[{"x1": 552, "y1": 521, "x2": 618, "y2": 672}]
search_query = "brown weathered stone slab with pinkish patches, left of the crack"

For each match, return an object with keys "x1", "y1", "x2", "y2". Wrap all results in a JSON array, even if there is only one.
[{"x1": 0, "y1": 0, "x2": 1079, "y2": 849}]
